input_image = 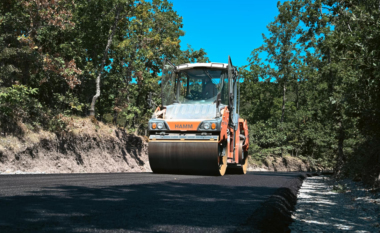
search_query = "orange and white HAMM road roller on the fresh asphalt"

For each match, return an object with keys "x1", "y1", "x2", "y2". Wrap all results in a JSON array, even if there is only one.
[{"x1": 148, "y1": 57, "x2": 249, "y2": 176}]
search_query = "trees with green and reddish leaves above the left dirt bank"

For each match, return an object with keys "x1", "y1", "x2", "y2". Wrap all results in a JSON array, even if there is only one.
[{"x1": 0, "y1": 0, "x2": 208, "y2": 136}]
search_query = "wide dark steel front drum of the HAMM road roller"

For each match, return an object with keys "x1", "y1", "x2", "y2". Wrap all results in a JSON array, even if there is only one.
[{"x1": 148, "y1": 140, "x2": 227, "y2": 176}]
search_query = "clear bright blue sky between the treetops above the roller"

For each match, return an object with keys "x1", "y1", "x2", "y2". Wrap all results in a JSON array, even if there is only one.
[{"x1": 169, "y1": 0, "x2": 284, "y2": 66}]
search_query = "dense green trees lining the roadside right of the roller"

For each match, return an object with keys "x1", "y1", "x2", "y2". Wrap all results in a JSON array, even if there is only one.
[{"x1": 241, "y1": 0, "x2": 380, "y2": 184}]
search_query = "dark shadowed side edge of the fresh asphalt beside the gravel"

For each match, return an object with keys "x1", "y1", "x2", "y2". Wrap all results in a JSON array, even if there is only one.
[{"x1": 235, "y1": 172, "x2": 321, "y2": 233}]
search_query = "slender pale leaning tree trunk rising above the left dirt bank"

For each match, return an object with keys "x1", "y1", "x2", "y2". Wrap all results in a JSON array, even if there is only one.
[{"x1": 90, "y1": 7, "x2": 120, "y2": 117}]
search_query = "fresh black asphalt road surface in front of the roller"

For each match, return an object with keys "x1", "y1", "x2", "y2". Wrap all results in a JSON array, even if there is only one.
[{"x1": 0, "y1": 172, "x2": 300, "y2": 232}]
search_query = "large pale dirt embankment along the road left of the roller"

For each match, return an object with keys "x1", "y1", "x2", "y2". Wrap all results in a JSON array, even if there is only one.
[{"x1": 0, "y1": 120, "x2": 151, "y2": 173}]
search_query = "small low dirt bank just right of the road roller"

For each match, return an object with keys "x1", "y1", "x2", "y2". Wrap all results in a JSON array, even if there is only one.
[{"x1": 248, "y1": 155, "x2": 328, "y2": 172}]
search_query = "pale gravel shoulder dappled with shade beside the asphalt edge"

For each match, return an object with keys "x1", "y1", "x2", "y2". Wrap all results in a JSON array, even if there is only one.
[{"x1": 290, "y1": 176, "x2": 380, "y2": 232}]
